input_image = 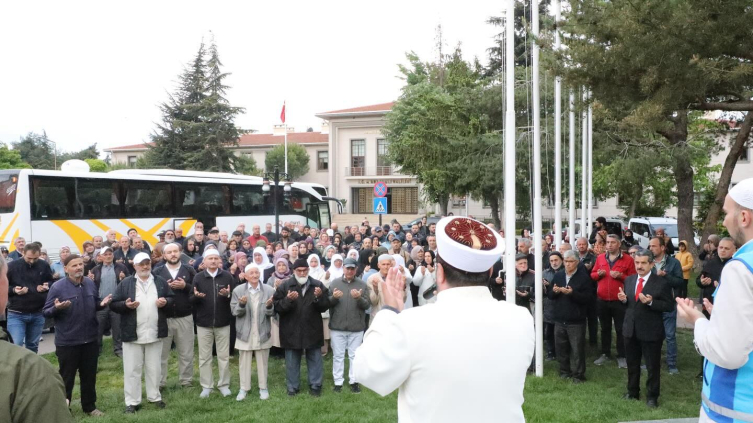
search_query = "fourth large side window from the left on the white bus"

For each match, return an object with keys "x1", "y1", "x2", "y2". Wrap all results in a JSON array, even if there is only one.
[{"x1": 175, "y1": 184, "x2": 229, "y2": 216}]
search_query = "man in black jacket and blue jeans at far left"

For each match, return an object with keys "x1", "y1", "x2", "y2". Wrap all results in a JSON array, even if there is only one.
[{"x1": 8, "y1": 242, "x2": 54, "y2": 353}]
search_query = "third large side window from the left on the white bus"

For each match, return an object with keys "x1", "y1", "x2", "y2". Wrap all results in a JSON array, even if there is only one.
[{"x1": 123, "y1": 181, "x2": 173, "y2": 217}]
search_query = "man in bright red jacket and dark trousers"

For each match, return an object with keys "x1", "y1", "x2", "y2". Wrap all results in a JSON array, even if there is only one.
[{"x1": 591, "y1": 235, "x2": 635, "y2": 369}]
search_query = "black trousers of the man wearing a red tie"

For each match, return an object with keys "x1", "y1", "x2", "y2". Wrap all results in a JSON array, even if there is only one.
[{"x1": 625, "y1": 336, "x2": 664, "y2": 399}]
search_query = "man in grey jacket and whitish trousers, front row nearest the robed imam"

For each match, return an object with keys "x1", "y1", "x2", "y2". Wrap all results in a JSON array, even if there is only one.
[{"x1": 329, "y1": 258, "x2": 371, "y2": 393}]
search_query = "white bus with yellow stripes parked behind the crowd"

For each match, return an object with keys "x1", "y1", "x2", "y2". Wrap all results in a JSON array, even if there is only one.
[{"x1": 0, "y1": 169, "x2": 330, "y2": 257}]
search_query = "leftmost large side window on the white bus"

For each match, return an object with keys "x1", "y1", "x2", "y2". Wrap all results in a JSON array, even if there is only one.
[{"x1": 29, "y1": 176, "x2": 76, "y2": 219}]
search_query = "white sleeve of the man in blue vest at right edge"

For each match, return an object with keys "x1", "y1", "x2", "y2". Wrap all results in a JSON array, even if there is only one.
[{"x1": 694, "y1": 261, "x2": 753, "y2": 369}]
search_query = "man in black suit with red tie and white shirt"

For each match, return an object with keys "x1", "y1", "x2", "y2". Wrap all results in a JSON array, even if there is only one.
[{"x1": 617, "y1": 250, "x2": 675, "y2": 408}]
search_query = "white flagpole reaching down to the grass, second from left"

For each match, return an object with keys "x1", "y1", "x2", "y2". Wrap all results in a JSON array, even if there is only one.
[{"x1": 531, "y1": 0, "x2": 544, "y2": 377}]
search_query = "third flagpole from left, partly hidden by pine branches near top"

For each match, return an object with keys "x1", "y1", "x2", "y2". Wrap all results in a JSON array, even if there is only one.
[{"x1": 553, "y1": 0, "x2": 562, "y2": 251}]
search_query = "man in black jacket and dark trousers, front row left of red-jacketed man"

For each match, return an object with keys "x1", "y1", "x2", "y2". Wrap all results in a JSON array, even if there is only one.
[{"x1": 548, "y1": 250, "x2": 592, "y2": 383}]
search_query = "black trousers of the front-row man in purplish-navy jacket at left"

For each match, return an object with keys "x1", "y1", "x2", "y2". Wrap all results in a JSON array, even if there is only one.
[{"x1": 55, "y1": 341, "x2": 99, "y2": 413}]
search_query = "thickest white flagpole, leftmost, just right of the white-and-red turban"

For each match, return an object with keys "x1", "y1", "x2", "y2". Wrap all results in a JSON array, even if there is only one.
[{"x1": 505, "y1": 0, "x2": 515, "y2": 304}]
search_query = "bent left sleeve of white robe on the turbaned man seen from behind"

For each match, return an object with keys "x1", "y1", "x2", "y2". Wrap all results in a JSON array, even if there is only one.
[{"x1": 353, "y1": 310, "x2": 411, "y2": 396}]
